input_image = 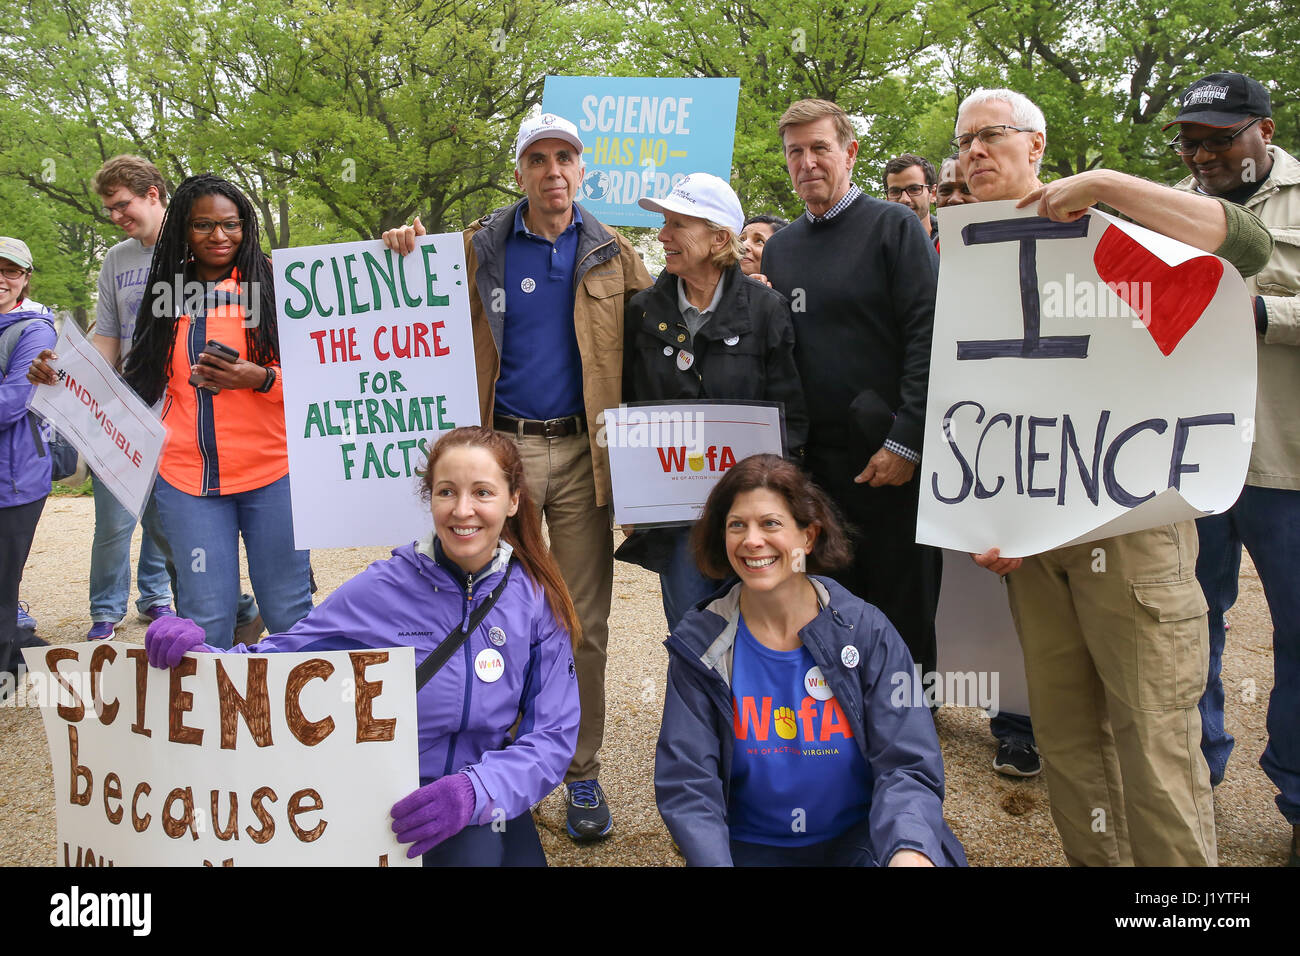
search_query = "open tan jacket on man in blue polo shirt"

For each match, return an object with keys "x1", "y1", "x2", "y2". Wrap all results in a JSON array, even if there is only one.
[{"x1": 464, "y1": 200, "x2": 654, "y2": 506}]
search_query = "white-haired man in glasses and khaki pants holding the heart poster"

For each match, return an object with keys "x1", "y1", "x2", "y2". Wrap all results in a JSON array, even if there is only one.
[{"x1": 953, "y1": 90, "x2": 1273, "y2": 866}]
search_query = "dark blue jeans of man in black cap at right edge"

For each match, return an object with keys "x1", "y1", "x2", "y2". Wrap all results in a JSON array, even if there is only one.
[{"x1": 1196, "y1": 485, "x2": 1300, "y2": 825}]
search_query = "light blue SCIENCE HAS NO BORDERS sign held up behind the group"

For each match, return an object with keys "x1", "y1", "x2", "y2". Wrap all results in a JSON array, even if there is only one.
[{"x1": 542, "y1": 77, "x2": 740, "y2": 228}]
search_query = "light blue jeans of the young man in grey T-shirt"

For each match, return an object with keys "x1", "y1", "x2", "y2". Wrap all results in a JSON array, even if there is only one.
[{"x1": 90, "y1": 481, "x2": 172, "y2": 623}]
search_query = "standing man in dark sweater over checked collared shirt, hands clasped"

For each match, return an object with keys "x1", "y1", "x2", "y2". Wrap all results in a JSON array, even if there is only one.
[{"x1": 763, "y1": 100, "x2": 940, "y2": 672}]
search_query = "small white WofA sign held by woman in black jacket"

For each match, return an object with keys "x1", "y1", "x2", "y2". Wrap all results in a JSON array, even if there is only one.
[{"x1": 597, "y1": 402, "x2": 785, "y2": 527}]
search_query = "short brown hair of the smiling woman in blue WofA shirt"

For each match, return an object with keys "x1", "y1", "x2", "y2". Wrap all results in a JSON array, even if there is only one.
[{"x1": 690, "y1": 455, "x2": 853, "y2": 579}]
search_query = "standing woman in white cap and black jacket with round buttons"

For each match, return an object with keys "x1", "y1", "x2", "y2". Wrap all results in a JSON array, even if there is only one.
[{"x1": 618, "y1": 173, "x2": 807, "y2": 630}]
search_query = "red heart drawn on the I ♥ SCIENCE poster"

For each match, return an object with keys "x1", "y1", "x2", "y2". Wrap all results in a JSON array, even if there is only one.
[{"x1": 1092, "y1": 226, "x2": 1223, "y2": 355}]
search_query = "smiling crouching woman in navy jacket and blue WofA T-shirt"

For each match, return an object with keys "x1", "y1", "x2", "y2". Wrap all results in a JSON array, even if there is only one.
[{"x1": 655, "y1": 455, "x2": 966, "y2": 866}]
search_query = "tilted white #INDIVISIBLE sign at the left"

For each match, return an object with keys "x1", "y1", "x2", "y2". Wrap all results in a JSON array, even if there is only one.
[{"x1": 30, "y1": 321, "x2": 166, "y2": 518}]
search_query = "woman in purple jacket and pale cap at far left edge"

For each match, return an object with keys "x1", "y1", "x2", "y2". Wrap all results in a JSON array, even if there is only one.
[{"x1": 0, "y1": 235, "x2": 57, "y2": 700}]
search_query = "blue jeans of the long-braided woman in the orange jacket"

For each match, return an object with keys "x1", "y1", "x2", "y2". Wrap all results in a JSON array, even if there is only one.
[{"x1": 153, "y1": 475, "x2": 312, "y2": 648}]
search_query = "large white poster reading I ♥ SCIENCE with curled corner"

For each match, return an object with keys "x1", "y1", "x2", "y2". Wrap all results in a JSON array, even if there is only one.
[{"x1": 917, "y1": 202, "x2": 1256, "y2": 557}]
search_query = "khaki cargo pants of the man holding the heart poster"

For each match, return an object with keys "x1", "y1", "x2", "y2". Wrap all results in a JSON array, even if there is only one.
[{"x1": 1008, "y1": 522, "x2": 1218, "y2": 866}]
